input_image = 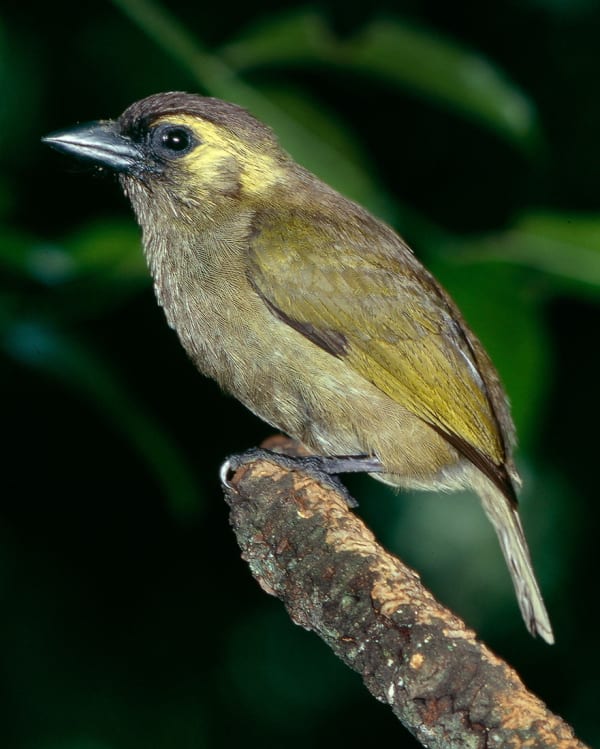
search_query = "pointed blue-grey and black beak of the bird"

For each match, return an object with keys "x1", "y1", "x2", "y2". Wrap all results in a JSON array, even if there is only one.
[{"x1": 42, "y1": 120, "x2": 142, "y2": 173}]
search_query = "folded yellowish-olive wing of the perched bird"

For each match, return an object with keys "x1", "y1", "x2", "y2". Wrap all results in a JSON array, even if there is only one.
[{"x1": 249, "y1": 207, "x2": 506, "y2": 482}]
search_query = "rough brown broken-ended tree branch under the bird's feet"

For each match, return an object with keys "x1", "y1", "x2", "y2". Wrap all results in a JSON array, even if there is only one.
[{"x1": 226, "y1": 448, "x2": 584, "y2": 749}]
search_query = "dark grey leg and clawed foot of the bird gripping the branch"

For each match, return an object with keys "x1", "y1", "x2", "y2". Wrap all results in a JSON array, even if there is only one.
[{"x1": 220, "y1": 447, "x2": 384, "y2": 507}]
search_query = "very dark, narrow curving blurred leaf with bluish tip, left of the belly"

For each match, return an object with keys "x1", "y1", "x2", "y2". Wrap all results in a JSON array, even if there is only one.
[{"x1": 0, "y1": 319, "x2": 201, "y2": 517}]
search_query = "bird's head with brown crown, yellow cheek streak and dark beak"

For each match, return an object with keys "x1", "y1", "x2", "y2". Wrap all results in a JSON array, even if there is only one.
[{"x1": 44, "y1": 92, "x2": 287, "y2": 224}]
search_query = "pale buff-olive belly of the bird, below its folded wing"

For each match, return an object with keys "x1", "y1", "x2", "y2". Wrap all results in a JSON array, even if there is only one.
[{"x1": 167, "y1": 280, "x2": 465, "y2": 489}]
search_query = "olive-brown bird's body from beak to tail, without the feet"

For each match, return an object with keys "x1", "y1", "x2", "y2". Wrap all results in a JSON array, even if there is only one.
[{"x1": 47, "y1": 92, "x2": 553, "y2": 642}]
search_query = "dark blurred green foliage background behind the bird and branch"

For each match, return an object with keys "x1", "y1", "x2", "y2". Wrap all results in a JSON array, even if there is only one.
[{"x1": 0, "y1": 0, "x2": 600, "y2": 749}]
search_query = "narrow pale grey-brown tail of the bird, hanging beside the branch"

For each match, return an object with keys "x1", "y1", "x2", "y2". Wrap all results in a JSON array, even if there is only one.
[{"x1": 478, "y1": 482, "x2": 554, "y2": 644}]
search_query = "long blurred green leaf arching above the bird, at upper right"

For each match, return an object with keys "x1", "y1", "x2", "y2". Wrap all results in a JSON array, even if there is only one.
[{"x1": 222, "y1": 9, "x2": 542, "y2": 149}]
